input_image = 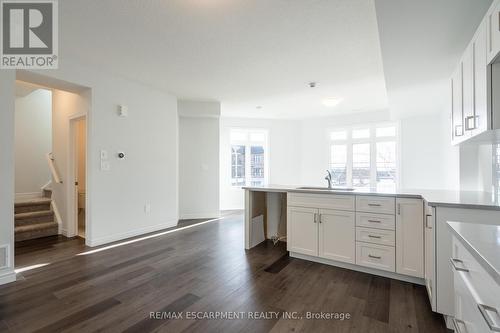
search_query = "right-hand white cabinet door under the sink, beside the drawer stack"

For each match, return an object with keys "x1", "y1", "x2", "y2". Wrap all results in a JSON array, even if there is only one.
[{"x1": 319, "y1": 209, "x2": 356, "y2": 264}]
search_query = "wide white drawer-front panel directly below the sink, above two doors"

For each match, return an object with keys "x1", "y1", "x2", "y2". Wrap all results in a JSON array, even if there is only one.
[{"x1": 287, "y1": 192, "x2": 355, "y2": 211}]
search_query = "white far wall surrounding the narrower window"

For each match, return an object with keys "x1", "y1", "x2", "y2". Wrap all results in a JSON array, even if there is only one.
[{"x1": 220, "y1": 118, "x2": 301, "y2": 210}]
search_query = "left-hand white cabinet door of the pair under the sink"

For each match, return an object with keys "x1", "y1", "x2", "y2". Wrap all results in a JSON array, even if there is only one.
[{"x1": 287, "y1": 206, "x2": 318, "y2": 256}]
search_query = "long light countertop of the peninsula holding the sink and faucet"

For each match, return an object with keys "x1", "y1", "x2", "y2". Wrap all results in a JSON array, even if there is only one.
[{"x1": 243, "y1": 185, "x2": 500, "y2": 210}]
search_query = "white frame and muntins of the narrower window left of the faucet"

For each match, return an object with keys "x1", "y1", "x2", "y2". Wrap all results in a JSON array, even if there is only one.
[{"x1": 229, "y1": 127, "x2": 270, "y2": 188}]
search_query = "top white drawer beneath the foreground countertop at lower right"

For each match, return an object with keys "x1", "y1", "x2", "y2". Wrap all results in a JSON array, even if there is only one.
[{"x1": 452, "y1": 237, "x2": 500, "y2": 316}]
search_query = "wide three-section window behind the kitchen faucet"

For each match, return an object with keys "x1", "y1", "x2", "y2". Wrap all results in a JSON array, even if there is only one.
[{"x1": 329, "y1": 124, "x2": 398, "y2": 190}]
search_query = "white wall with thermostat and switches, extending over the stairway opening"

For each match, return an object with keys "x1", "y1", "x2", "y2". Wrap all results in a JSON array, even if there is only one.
[{"x1": 20, "y1": 59, "x2": 179, "y2": 246}]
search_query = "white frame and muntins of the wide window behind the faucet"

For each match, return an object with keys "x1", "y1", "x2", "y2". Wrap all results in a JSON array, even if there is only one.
[{"x1": 327, "y1": 122, "x2": 401, "y2": 189}]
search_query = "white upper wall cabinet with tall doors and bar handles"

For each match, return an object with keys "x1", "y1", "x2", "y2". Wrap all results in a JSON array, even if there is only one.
[{"x1": 450, "y1": 20, "x2": 490, "y2": 144}]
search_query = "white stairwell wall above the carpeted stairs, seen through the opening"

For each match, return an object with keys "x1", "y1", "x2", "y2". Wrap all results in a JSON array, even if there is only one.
[{"x1": 15, "y1": 89, "x2": 52, "y2": 197}]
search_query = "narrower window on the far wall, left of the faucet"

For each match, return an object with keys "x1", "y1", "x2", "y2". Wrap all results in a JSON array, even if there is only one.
[{"x1": 230, "y1": 129, "x2": 268, "y2": 187}]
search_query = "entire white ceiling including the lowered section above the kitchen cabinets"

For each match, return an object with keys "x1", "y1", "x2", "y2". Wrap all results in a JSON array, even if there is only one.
[{"x1": 59, "y1": 0, "x2": 491, "y2": 118}]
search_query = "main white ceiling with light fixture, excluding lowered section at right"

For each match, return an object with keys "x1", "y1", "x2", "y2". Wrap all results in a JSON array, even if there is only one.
[{"x1": 59, "y1": 0, "x2": 387, "y2": 118}]
